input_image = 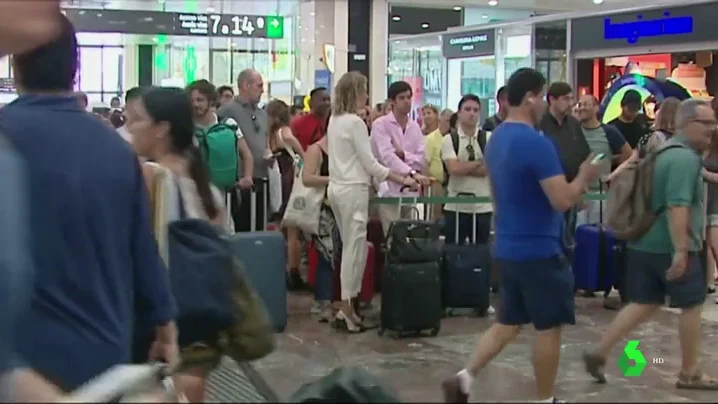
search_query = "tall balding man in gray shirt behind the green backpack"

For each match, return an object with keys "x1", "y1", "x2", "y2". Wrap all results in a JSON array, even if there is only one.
[{"x1": 217, "y1": 69, "x2": 272, "y2": 232}]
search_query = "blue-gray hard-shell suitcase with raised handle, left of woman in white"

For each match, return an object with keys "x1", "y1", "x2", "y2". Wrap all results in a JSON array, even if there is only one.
[{"x1": 229, "y1": 181, "x2": 287, "y2": 332}]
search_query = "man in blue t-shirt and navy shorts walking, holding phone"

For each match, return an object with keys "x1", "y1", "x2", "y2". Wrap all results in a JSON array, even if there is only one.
[{"x1": 442, "y1": 68, "x2": 597, "y2": 403}]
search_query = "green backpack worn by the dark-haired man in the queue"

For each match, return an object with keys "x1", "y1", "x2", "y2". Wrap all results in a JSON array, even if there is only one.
[{"x1": 195, "y1": 122, "x2": 239, "y2": 190}]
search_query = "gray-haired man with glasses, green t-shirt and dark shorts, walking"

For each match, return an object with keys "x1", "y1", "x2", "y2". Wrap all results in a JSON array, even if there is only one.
[{"x1": 583, "y1": 99, "x2": 718, "y2": 390}]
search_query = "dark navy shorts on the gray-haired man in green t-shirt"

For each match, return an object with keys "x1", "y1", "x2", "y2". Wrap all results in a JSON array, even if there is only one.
[{"x1": 626, "y1": 248, "x2": 707, "y2": 309}]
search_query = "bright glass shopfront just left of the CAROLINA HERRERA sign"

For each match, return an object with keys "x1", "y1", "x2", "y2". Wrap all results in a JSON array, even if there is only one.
[{"x1": 387, "y1": 35, "x2": 445, "y2": 107}]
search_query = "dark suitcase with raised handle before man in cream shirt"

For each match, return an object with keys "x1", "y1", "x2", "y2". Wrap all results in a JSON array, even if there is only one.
[{"x1": 442, "y1": 200, "x2": 493, "y2": 317}]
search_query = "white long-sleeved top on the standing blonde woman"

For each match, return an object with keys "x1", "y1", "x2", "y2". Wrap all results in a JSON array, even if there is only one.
[{"x1": 327, "y1": 114, "x2": 389, "y2": 186}]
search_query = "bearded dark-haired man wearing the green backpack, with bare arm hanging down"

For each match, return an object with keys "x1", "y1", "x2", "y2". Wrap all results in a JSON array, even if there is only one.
[{"x1": 187, "y1": 80, "x2": 254, "y2": 193}]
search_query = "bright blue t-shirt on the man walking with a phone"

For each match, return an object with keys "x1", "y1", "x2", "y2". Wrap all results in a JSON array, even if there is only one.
[{"x1": 485, "y1": 122, "x2": 564, "y2": 261}]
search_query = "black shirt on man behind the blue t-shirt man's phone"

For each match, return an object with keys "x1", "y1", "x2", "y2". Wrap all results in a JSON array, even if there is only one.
[{"x1": 539, "y1": 112, "x2": 591, "y2": 181}]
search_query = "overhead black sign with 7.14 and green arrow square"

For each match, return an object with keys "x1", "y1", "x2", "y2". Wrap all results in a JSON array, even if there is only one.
[{"x1": 63, "y1": 8, "x2": 284, "y2": 39}]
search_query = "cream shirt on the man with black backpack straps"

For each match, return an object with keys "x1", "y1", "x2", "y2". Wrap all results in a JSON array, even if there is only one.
[{"x1": 441, "y1": 128, "x2": 493, "y2": 213}]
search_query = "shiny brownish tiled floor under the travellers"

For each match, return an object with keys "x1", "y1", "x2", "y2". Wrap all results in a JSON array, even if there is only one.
[{"x1": 256, "y1": 296, "x2": 718, "y2": 402}]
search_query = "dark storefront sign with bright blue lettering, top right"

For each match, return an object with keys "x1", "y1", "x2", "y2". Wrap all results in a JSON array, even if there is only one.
[{"x1": 571, "y1": 2, "x2": 718, "y2": 51}]
